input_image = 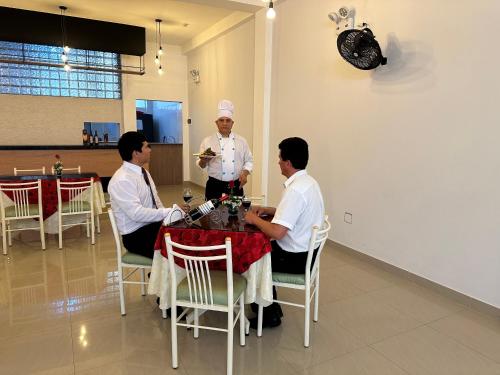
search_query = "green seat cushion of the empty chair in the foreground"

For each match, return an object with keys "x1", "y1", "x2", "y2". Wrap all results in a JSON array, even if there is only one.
[{"x1": 177, "y1": 271, "x2": 247, "y2": 305}]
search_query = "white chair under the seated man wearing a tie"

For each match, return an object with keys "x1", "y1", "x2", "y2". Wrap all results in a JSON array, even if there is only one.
[{"x1": 108, "y1": 209, "x2": 161, "y2": 318}]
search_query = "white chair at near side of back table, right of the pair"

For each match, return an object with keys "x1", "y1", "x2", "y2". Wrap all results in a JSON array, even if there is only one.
[{"x1": 57, "y1": 178, "x2": 95, "y2": 249}]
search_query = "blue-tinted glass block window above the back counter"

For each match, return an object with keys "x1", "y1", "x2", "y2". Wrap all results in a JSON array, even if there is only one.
[{"x1": 0, "y1": 41, "x2": 121, "y2": 99}]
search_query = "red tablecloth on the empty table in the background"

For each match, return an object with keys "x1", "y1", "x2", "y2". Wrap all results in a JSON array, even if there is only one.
[{"x1": 0, "y1": 177, "x2": 99, "y2": 220}]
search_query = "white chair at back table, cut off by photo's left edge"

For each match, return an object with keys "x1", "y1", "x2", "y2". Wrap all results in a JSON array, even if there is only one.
[{"x1": 0, "y1": 180, "x2": 45, "y2": 255}]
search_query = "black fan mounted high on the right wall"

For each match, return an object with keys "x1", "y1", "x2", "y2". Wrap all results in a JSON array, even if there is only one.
[{"x1": 328, "y1": 7, "x2": 387, "y2": 70}]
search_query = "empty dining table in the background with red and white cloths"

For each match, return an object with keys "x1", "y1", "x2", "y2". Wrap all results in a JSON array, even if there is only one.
[{"x1": 0, "y1": 172, "x2": 106, "y2": 234}]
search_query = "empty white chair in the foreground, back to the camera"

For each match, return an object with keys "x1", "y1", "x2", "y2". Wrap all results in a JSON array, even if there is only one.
[{"x1": 165, "y1": 233, "x2": 247, "y2": 375}]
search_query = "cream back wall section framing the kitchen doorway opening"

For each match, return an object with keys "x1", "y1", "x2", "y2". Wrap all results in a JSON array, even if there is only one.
[{"x1": 122, "y1": 39, "x2": 189, "y2": 180}]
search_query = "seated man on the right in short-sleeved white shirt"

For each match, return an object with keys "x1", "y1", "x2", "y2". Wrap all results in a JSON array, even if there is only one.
[{"x1": 245, "y1": 137, "x2": 325, "y2": 327}]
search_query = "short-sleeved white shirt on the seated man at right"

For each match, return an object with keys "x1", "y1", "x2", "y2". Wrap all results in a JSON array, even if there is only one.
[{"x1": 272, "y1": 169, "x2": 325, "y2": 253}]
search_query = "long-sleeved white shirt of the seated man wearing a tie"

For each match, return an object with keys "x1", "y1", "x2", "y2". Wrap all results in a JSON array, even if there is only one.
[{"x1": 108, "y1": 161, "x2": 173, "y2": 235}]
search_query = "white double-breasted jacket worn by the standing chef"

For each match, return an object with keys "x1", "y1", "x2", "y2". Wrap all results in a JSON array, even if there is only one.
[{"x1": 198, "y1": 132, "x2": 253, "y2": 181}]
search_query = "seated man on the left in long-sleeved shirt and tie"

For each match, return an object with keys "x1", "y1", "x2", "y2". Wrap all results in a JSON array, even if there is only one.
[{"x1": 108, "y1": 131, "x2": 189, "y2": 258}]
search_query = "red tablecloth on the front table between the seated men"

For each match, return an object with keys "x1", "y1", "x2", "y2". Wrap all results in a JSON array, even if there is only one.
[{"x1": 155, "y1": 226, "x2": 271, "y2": 274}]
